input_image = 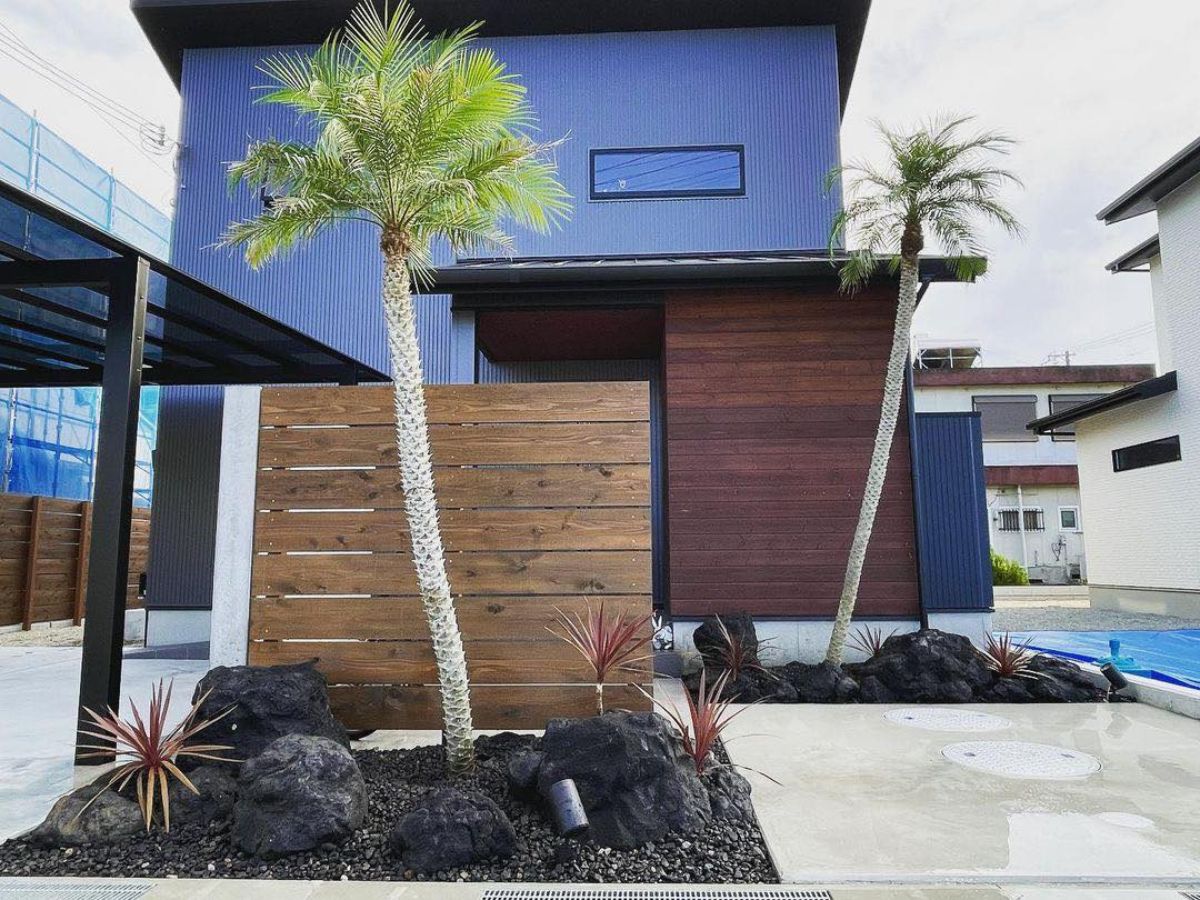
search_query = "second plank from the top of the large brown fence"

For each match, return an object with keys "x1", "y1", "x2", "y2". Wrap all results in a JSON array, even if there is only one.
[{"x1": 258, "y1": 422, "x2": 650, "y2": 467}]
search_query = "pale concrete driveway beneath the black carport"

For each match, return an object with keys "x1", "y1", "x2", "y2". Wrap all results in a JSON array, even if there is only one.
[{"x1": 0, "y1": 647, "x2": 208, "y2": 840}]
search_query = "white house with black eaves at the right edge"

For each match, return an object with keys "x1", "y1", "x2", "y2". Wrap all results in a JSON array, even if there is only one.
[{"x1": 1030, "y1": 140, "x2": 1200, "y2": 616}]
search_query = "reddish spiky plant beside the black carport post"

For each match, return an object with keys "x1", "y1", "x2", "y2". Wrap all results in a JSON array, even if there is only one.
[{"x1": 76, "y1": 679, "x2": 233, "y2": 832}]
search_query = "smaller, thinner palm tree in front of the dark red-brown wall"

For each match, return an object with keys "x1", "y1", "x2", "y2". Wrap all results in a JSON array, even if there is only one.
[{"x1": 826, "y1": 118, "x2": 1021, "y2": 664}]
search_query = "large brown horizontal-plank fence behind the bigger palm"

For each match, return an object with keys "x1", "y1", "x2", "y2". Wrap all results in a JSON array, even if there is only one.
[{"x1": 248, "y1": 382, "x2": 652, "y2": 728}]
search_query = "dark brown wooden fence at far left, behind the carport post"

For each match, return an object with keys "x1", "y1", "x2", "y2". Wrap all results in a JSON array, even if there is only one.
[{"x1": 0, "y1": 493, "x2": 150, "y2": 630}]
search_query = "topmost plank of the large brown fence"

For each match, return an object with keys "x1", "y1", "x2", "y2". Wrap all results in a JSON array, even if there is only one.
[{"x1": 262, "y1": 382, "x2": 650, "y2": 426}]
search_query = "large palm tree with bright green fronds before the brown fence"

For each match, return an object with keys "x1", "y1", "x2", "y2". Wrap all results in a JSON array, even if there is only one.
[{"x1": 223, "y1": 0, "x2": 570, "y2": 773}]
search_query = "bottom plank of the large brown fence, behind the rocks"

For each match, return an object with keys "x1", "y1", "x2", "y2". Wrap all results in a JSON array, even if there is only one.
[{"x1": 329, "y1": 684, "x2": 652, "y2": 731}]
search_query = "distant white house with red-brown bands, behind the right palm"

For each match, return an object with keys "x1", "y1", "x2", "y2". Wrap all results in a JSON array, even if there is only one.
[{"x1": 916, "y1": 362, "x2": 1154, "y2": 584}]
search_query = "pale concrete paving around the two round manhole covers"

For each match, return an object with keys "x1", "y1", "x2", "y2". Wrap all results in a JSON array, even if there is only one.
[{"x1": 727, "y1": 704, "x2": 1200, "y2": 883}]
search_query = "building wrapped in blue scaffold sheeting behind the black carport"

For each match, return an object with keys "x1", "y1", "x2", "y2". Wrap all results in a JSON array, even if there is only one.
[{"x1": 0, "y1": 96, "x2": 170, "y2": 505}]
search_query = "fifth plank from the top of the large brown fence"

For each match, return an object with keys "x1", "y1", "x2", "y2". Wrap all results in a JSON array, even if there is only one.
[{"x1": 251, "y1": 551, "x2": 650, "y2": 596}]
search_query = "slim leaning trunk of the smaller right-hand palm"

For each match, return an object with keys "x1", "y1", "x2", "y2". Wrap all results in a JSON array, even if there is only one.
[{"x1": 826, "y1": 254, "x2": 918, "y2": 665}]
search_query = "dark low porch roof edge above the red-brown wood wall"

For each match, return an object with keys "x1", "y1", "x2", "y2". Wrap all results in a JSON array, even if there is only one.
[{"x1": 419, "y1": 253, "x2": 979, "y2": 294}]
